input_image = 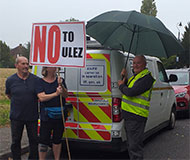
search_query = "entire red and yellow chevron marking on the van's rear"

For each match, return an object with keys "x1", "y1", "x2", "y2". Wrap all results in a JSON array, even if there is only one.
[{"x1": 63, "y1": 54, "x2": 112, "y2": 141}]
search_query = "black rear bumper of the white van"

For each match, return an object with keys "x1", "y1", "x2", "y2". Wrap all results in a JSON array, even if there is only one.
[{"x1": 63, "y1": 138, "x2": 127, "y2": 152}]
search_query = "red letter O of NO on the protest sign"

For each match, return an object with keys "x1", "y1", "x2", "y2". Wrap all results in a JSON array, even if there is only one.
[{"x1": 48, "y1": 25, "x2": 61, "y2": 63}]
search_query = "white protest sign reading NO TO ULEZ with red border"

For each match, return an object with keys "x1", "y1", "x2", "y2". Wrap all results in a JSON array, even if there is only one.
[{"x1": 30, "y1": 22, "x2": 86, "y2": 67}]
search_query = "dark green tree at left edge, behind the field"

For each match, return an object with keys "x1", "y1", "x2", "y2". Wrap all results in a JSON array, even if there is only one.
[{"x1": 0, "y1": 40, "x2": 14, "y2": 68}]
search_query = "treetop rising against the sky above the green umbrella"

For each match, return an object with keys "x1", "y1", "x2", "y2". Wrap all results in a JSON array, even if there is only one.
[{"x1": 141, "y1": 0, "x2": 157, "y2": 17}]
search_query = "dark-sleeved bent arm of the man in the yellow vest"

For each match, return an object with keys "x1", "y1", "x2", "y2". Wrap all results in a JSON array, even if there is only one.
[{"x1": 119, "y1": 74, "x2": 154, "y2": 97}]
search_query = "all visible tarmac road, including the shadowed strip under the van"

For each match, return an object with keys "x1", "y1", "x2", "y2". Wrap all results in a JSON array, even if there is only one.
[{"x1": 23, "y1": 118, "x2": 190, "y2": 160}]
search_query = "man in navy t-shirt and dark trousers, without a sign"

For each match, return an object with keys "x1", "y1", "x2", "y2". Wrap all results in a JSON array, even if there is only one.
[{"x1": 5, "y1": 56, "x2": 38, "y2": 160}]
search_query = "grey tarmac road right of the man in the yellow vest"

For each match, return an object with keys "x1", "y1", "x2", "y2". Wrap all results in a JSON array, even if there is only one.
[{"x1": 144, "y1": 118, "x2": 190, "y2": 160}]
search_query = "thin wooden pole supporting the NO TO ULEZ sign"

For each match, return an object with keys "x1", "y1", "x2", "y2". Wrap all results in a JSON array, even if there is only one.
[{"x1": 58, "y1": 69, "x2": 71, "y2": 160}]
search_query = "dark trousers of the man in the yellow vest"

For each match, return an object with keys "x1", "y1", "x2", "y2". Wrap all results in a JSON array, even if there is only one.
[{"x1": 125, "y1": 120, "x2": 146, "y2": 160}]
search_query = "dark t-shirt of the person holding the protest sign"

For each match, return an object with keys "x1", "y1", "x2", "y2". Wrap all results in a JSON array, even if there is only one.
[{"x1": 37, "y1": 78, "x2": 67, "y2": 121}]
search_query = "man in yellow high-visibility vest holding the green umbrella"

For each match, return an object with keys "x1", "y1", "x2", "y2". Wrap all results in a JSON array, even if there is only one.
[{"x1": 118, "y1": 55, "x2": 155, "y2": 160}]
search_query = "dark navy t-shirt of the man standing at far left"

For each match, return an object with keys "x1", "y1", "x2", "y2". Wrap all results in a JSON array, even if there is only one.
[{"x1": 5, "y1": 73, "x2": 39, "y2": 121}]
